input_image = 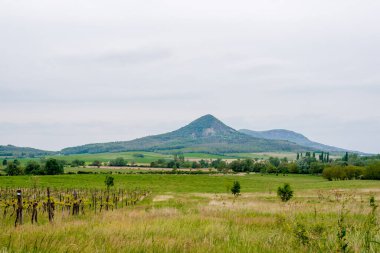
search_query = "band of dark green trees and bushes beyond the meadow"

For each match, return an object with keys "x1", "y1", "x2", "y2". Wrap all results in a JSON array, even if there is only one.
[{"x1": 3, "y1": 152, "x2": 380, "y2": 180}]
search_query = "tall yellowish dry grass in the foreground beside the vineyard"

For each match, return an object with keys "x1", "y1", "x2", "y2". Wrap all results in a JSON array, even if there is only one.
[{"x1": 0, "y1": 189, "x2": 380, "y2": 252}]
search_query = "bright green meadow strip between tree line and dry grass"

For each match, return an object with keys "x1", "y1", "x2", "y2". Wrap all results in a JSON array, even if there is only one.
[{"x1": 0, "y1": 173, "x2": 380, "y2": 193}]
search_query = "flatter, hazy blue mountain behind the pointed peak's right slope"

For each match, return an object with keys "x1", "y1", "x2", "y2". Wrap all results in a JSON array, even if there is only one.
[{"x1": 239, "y1": 129, "x2": 348, "y2": 153}]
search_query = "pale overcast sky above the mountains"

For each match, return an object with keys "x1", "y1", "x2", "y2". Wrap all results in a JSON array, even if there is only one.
[{"x1": 0, "y1": 0, "x2": 380, "y2": 153}]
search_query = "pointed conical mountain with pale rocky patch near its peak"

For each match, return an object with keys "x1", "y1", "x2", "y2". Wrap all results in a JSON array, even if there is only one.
[{"x1": 61, "y1": 115, "x2": 309, "y2": 154}]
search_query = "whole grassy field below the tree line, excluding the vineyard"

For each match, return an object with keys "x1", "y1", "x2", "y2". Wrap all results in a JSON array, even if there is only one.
[{"x1": 0, "y1": 175, "x2": 380, "y2": 252}]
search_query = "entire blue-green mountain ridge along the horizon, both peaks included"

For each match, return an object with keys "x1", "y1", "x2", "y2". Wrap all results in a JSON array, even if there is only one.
[{"x1": 0, "y1": 114, "x2": 354, "y2": 157}]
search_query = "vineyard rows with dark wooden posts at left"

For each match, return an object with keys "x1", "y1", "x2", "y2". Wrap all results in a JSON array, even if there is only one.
[{"x1": 0, "y1": 185, "x2": 150, "y2": 226}]
